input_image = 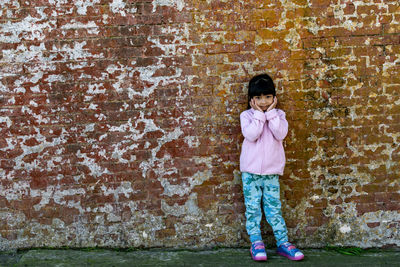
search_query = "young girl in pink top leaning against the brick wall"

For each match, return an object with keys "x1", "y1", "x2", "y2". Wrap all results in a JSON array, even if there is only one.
[{"x1": 240, "y1": 74, "x2": 304, "y2": 261}]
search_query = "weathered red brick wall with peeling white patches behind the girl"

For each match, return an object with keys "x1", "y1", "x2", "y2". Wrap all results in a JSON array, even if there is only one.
[{"x1": 0, "y1": 0, "x2": 400, "y2": 249}]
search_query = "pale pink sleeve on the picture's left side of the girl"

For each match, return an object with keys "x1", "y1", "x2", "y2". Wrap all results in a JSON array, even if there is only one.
[{"x1": 240, "y1": 110, "x2": 267, "y2": 142}]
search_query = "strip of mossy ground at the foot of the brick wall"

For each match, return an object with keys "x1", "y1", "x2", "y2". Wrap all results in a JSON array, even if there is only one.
[{"x1": 0, "y1": 248, "x2": 400, "y2": 267}]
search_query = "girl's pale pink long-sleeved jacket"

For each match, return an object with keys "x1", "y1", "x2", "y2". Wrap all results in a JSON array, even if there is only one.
[{"x1": 240, "y1": 108, "x2": 288, "y2": 175}]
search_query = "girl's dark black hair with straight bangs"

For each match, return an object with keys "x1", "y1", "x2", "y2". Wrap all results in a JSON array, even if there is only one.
[{"x1": 247, "y1": 74, "x2": 276, "y2": 109}]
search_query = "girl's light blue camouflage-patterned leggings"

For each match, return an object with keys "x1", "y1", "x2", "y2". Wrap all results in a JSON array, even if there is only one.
[{"x1": 242, "y1": 172, "x2": 288, "y2": 246}]
